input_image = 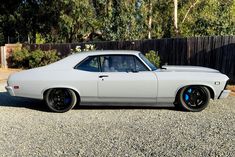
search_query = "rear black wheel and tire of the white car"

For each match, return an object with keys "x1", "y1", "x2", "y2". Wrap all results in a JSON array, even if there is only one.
[{"x1": 45, "y1": 88, "x2": 77, "y2": 113}]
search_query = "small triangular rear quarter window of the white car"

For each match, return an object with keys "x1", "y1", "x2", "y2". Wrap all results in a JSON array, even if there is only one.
[{"x1": 75, "y1": 56, "x2": 99, "y2": 72}]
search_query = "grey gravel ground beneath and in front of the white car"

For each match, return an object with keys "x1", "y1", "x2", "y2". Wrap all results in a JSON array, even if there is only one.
[{"x1": 0, "y1": 84, "x2": 235, "y2": 157}]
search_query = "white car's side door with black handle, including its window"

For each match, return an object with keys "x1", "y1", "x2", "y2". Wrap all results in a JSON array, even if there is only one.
[{"x1": 98, "y1": 55, "x2": 157, "y2": 102}]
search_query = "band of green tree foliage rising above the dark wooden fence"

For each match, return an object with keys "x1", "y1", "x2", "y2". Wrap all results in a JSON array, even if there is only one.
[{"x1": 0, "y1": 0, "x2": 235, "y2": 44}]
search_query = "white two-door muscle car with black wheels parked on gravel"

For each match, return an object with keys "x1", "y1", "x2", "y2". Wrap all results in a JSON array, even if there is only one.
[{"x1": 6, "y1": 50, "x2": 230, "y2": 112}]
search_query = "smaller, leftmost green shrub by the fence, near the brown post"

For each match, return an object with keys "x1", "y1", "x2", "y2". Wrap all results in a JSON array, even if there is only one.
[{"x1": 11, "y1": 48, "x2": 30, "y2": 68}]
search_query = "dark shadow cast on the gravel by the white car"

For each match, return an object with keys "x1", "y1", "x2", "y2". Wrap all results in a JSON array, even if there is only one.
[{"x1": 0, "y1": 92, "x2": 180, "y2": 112}]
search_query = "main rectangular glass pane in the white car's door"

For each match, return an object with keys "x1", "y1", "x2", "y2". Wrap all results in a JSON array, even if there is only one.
[{"x1": 100, "y1": 55, "x2": 135, "y2": 72}]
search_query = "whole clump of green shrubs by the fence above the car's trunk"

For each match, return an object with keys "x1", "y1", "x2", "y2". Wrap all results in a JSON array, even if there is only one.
[{"x1": 11, "y1": 48, "x2": 59, "y2": 69}]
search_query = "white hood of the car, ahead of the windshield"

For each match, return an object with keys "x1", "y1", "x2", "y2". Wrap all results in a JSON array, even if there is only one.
[{"x1": 162, "y1": 65, "x2": 219, "y2": 73}]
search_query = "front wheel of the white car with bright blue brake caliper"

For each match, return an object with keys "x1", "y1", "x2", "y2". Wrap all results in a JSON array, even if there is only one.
[{"x1": 179, "y1": 86, "x2": 210, "y2": 112}]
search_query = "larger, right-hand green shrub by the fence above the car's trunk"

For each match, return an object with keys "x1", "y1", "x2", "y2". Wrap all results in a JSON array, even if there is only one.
[{"x1": 29, "y1": 49, "x2": 59, "y2": 68}]
